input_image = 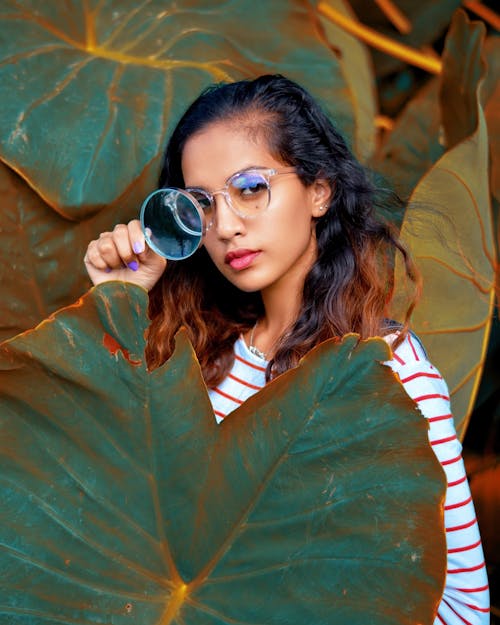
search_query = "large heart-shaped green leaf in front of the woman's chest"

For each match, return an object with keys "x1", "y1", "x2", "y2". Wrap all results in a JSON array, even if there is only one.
[{"x1": 0, "y1": 282, "x2": 446, "y2": 625}]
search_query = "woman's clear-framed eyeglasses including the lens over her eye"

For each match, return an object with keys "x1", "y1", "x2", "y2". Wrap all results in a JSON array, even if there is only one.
[{"x1": 185, "y1": 167, "x2": 295, "y2": 230}]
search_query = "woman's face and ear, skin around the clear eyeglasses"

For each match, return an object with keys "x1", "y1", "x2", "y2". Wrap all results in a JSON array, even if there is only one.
[{"x1": 182, "y1": 122, "x2": 330, "y2": 294}]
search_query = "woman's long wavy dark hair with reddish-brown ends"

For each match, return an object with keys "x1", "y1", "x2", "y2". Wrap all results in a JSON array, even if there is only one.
[{"x1": 146, "y1": 75, "x2": 418, "y2": 387}]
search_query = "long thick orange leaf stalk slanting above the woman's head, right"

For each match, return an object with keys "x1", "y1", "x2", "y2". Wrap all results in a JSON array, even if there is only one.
[{"x1": 317, "y1": 2, "x2": 443, "y2": 74}]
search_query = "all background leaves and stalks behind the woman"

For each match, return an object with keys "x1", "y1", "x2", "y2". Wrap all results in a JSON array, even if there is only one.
[{"x1": 0, "y1": 0, "x2": 500, "y2": 620}]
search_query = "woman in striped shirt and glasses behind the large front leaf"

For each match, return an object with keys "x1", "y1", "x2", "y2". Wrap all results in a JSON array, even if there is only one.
[{"x1": 85, "y1": 76, "x2": 488, "y2": 624}]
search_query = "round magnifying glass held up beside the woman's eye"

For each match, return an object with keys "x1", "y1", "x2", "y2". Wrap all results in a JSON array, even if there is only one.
[{"x1": 140, "y1": 187, "x2": 205, "y2": 260}]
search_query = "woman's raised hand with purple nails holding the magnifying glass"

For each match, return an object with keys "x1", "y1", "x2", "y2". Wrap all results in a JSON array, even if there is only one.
[{"x1": 84, "y1": 219, "x2": 167, "y2": 291}]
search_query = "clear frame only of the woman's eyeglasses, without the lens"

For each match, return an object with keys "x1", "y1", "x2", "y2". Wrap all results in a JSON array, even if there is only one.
[{"x1": 184, "y1": 167, "x2": 297, "y2": 231}]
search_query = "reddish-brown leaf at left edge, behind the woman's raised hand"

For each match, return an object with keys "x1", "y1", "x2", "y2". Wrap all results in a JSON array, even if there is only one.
[{"x1": 0, "y1": 162, "x2": 147, "y2": 340}]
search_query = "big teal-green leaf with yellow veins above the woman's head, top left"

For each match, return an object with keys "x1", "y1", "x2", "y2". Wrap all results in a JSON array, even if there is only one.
[{"x1": 0, "y1": 0, "x2": 353, "y2": 218}]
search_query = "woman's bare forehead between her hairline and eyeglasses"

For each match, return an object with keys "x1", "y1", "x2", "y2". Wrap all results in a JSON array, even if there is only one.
[{"x1": 181, "y1": 122, "x2": 283, "y2": 189}]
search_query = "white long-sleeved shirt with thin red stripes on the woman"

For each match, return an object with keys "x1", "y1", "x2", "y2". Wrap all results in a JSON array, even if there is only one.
[{"x1": 209, "y1": 334, "x2": 489, "y2": 625}]
